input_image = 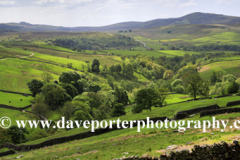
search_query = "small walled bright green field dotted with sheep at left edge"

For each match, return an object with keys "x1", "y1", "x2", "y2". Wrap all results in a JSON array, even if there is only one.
[{"x1": 0, "y1": 92, "x2": 33, "y2": 107}]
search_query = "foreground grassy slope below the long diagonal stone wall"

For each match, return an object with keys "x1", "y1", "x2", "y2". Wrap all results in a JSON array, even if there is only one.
[{"x1": 4, "y1": 113, "x2": 240, "y2": 160}]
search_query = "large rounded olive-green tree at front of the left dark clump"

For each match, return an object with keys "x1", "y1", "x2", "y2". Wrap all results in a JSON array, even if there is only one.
[{"x1": 41, "y1": 83, "x2": 72, "y2": 110}]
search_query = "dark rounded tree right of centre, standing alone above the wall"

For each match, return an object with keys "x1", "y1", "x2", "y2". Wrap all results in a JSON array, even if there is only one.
[{"x1": 135, "y1": 88, "x2": 156, "y2": 111}]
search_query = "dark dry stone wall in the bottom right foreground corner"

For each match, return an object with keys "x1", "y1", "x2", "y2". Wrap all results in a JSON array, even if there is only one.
[{"x1": 113, "y1": 141, "x2": 240, "y2": 160}]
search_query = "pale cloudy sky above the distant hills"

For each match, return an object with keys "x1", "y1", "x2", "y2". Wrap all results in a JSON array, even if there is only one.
[{"x1": 0, "y1": 0, "x2": 240, "y2": 27}]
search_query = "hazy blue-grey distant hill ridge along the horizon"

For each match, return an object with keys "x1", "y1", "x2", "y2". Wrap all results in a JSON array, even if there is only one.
[{"x1": 0, "y1": 12, "x2": 240, "y2": 31}]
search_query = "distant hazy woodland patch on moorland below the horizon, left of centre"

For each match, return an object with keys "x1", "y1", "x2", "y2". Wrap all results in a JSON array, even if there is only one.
[{"x1": 52, "y1": 34, "x2": 139, "y2": 51}]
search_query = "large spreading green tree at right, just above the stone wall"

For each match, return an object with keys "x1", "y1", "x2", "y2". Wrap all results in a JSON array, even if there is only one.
[{"x1": 184, "y1": 74, "x2": 209, "y2": 99}]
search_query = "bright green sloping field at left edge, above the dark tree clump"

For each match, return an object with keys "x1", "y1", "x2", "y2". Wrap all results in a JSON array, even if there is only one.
[{"x1": 0, "y1": 56, "x2": 70, "y2": 93}]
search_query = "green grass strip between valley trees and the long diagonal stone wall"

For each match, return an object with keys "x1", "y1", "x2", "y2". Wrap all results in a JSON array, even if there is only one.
[{"x1": 11, "y1": 95, "x2": 240, "y2": 144}]
